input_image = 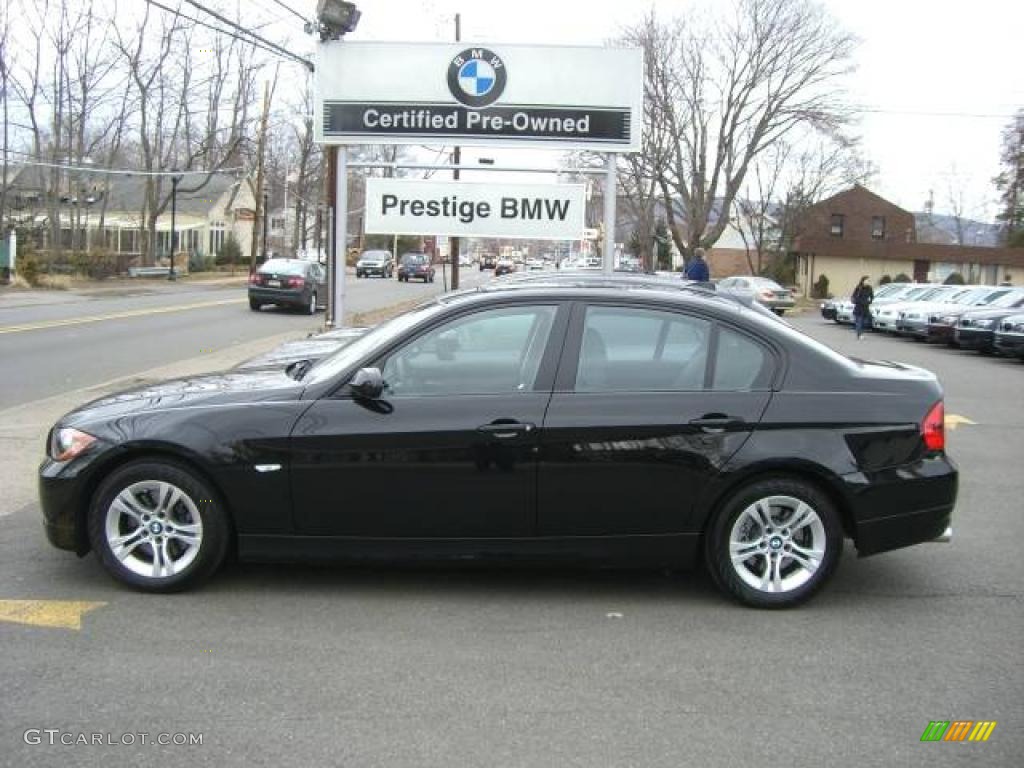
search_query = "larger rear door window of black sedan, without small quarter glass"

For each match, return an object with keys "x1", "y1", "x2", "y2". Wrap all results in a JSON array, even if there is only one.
[{"x1": 575, "y1": 306, "x2": 711, "y2": 392}]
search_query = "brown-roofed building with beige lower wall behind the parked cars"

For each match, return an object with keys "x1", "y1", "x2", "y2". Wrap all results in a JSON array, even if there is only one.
[{"x1": 794, "y1": 184, "x2": 1024, "y2": 296}]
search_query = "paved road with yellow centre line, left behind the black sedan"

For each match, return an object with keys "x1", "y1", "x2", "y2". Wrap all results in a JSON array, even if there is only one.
[{"x1": 0, "y1": 269, "x2": 492, "y2": 409}]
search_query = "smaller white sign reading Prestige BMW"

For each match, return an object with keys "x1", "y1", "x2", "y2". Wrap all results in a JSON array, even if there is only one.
[{"x1": 366, "y1": 178, "x2": 585, "y2": 240}]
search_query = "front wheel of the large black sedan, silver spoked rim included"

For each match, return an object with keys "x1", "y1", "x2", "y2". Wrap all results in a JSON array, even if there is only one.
[{"x1": 88, "y1": 461, "x2": 230, "y2": 592}]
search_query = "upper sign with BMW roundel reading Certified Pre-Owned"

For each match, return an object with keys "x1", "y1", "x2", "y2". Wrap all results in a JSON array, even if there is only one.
[{"x1": 316, "y1": 42, "x2": 643, "y2": 152}]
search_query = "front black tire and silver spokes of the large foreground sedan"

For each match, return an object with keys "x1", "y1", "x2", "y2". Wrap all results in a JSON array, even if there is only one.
[{"x1": 88, "y1": 459, "x2": 231, "y2": 592}]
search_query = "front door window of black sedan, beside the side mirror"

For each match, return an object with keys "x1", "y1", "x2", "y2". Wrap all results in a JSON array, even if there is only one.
[{"x1": 381, "y1": 306, "x2": 557, "y2": 397}]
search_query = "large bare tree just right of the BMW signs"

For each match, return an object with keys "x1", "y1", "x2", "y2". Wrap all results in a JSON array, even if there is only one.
[{"x1": 628, "y1": 0, "x2": 853, "y2": 262}]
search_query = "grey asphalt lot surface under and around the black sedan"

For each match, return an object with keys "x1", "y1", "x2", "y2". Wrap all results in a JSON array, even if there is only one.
[{"x1": 0, "y1": 314, "x2": 1024, "y2": 766}]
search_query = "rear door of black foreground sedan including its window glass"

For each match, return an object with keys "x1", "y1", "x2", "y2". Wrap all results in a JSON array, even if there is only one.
[{"x1": 538, "y1": 303, "x2": 778, "y2": 537}]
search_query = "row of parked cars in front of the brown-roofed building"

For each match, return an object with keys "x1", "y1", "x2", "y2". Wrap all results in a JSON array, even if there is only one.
[{"x1": 821, "y1": 283, "x2": 1024, "y2": 358}]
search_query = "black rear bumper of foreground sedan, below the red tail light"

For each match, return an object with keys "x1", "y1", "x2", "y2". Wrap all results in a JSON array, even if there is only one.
[{"x1": 844, "y1": 456, "x2": 958, "y2": 557}]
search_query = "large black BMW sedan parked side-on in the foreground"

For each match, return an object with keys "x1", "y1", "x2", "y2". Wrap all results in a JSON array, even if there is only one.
[{"x1": 40, "y1": 279, "x2": 957, "y2": 607}]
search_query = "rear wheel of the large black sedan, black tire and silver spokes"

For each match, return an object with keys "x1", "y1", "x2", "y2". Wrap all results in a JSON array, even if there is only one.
[{"x1": 705, "y1": 477, "x2": 843, "y2": 608}]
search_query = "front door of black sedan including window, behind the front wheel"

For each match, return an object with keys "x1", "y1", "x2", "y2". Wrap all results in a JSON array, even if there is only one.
[{"x1": 292, "y1": 305, "x2": 563, "y2": 539}]
